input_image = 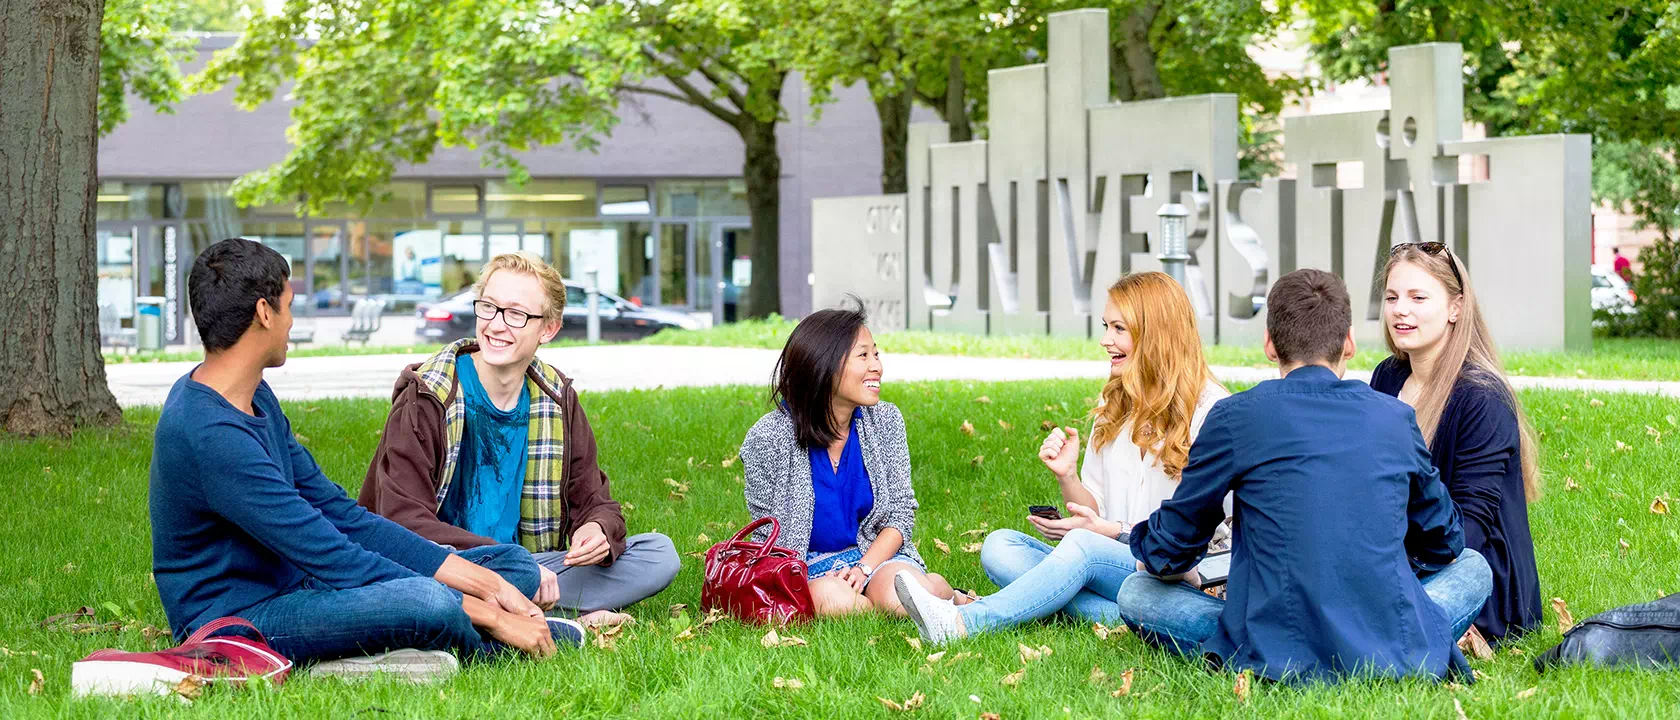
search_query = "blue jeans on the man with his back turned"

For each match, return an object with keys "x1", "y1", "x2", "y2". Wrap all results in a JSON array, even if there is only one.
[{"x1": 1117, "y1": 549, "x2": 1494, "y2": 658}]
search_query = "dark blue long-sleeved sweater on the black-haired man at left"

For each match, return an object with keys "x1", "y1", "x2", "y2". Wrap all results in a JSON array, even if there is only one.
[{"x1": 148, "y1": 373, "x2": 449, "y2": 639}]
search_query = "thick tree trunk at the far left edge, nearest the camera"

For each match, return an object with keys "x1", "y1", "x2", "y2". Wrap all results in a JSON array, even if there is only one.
[{"x1": 0, "y1": 0, "x2": 123, "y2": 435}]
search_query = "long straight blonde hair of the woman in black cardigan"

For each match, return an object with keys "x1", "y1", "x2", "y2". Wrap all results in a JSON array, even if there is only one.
[{"x1": 1381, "y1": 245, "x2": 1541, "y2": 502}]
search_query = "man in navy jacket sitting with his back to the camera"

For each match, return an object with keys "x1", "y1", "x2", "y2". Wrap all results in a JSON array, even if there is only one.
[{"x1": 1119, "y1": 270, "x2": 1492, "y2": 681}]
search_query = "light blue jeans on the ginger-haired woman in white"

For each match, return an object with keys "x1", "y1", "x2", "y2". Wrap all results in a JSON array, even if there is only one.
[{"x1": 958, "y1": 530, "x2": 1137, "y2": 633}]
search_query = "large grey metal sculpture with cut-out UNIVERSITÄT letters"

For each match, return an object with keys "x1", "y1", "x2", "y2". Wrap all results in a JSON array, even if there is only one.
[{"x1": 811, "y1": 10, "x2": 1593, "y2": 349}]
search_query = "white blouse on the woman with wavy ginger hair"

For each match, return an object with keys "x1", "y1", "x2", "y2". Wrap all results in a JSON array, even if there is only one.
[{"x1": 1079, "y1": 379, "x2": 1231, "y2": 525}]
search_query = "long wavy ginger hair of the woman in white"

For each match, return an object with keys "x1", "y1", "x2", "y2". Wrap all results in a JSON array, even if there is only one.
[{"x1": 1090, "y1": 272, "x2": 1213, "y2": 478}]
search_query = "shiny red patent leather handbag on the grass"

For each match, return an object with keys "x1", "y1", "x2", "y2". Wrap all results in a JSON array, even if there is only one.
[{"x1": 701, "y1": 517, "x2": 816, "y2": 624}]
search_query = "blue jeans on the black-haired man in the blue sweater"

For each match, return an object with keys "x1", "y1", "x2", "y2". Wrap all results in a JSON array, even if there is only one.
[{"x1": 240, "y1": 545, "x2": 543, "y2": 665}]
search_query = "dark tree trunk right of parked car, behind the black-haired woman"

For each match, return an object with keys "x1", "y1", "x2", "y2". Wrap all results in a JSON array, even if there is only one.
[{"x1": 739, "y1": 112, "x2": 781, "y2": 319}]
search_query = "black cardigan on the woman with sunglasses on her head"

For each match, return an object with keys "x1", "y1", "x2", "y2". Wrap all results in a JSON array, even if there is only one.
[{"x1": 1371, "y1": 357, "x2": 1541, "y2": 641}]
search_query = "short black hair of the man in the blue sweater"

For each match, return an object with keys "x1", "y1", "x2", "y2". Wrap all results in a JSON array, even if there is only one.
[{"x1": 186, "y1": 238, "x2": 292, "y2": 352}]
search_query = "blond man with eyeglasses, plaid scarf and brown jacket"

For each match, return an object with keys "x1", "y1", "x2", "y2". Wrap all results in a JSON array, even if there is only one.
[{"x1": 358, "y1": 252, "x2": 680, "y2": 624}]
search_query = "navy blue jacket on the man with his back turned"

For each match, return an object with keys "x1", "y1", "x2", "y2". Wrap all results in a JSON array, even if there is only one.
[{"x1": 1131, "y1": 366, "x2": 1470, "y2": 681}]
